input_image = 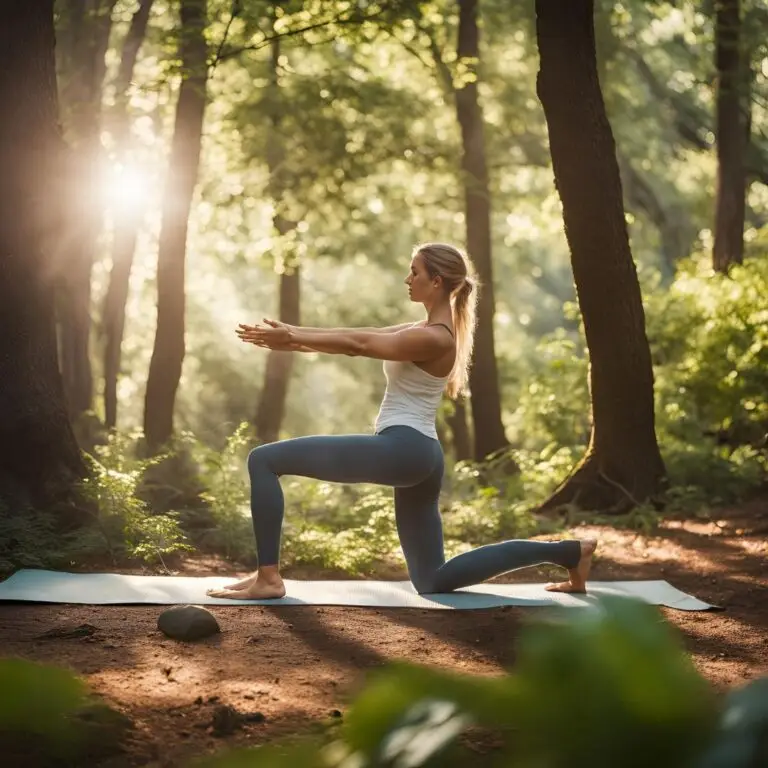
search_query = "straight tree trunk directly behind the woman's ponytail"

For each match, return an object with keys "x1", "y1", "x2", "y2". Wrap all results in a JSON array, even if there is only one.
[{"x1": 455, "y1": 0, "x2": 508, "y2": 461}]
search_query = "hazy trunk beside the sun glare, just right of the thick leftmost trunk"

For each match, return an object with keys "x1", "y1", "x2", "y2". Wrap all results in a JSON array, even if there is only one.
[{"x1": 57, "y1": 0, "x2": 116, "y2": 417}]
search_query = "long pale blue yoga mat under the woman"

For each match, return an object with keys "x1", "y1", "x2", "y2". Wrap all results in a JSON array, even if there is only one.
[{"x1": 0, "y1": 569, "x2": 715, "y2": 611}]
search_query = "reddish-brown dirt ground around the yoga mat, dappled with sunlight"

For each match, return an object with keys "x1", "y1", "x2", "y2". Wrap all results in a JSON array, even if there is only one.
[{"x1": 0, "y1": 499, "x2": 768, "y2": 768}]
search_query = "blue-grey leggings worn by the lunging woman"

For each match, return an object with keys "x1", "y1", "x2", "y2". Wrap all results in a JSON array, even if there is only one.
[{"x1": 248, "y1": 426, "x2": 581, "y2": 594}]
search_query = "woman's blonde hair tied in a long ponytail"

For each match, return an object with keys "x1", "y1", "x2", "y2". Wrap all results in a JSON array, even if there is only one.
[{"x1": 413, "y1": 243, "x2": 479, "y2": 398}]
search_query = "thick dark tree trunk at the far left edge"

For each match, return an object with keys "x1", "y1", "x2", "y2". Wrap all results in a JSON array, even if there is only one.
[{"x1": 0, "y1": 0, "x2": 85, "y2": 514}]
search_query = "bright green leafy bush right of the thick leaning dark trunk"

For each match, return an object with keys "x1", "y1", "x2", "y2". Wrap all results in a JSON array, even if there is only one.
[{"x1": 647, "y1": 252, "x2": 768, "y2": 503}]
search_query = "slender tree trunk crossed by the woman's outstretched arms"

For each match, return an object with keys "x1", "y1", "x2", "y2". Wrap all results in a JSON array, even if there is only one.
[{"x1": 255, "y1": 28, "x2": 301, "y2": 443}]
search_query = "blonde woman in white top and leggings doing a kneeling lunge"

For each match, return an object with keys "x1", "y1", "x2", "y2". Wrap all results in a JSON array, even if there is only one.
[{"x1": 208, "y1": 243, "x2": 596, "y2": 600}]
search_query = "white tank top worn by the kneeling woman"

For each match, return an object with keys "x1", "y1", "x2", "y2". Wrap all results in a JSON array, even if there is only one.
[{"x1": 375, "y1": 360, "x2": 448, "y2": 440}]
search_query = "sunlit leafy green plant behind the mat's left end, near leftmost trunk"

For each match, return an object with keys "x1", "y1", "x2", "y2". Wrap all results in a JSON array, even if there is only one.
[{"x1": 81, "y1": 434, "x2": 190, "y2": 563}]
